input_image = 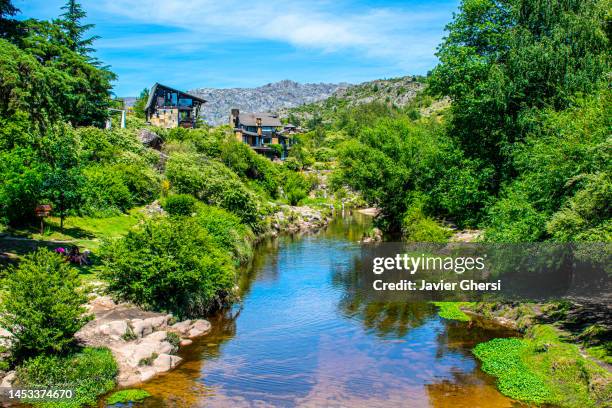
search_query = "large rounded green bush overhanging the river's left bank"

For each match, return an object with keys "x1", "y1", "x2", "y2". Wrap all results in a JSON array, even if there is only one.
[{"x1": 101, "y1": 217, "x2": 235, "y2": 317}]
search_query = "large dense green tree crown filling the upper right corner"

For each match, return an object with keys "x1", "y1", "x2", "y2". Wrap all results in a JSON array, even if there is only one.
[{"x1": 430, "y1": 0, "x2": 610, "y2": 182}]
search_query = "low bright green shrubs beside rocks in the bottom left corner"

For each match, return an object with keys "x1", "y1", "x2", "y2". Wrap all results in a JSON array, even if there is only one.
[{"x1": 16, "y1": 347, "x2": 118, "y2": 408}]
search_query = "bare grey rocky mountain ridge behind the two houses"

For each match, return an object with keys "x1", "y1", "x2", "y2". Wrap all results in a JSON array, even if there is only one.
[{"x1": 189, "y1": 80, "x2": 350, "y2": 125}]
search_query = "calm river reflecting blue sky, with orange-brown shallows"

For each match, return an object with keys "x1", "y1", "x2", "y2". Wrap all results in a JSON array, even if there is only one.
[{"x1": 137, "y1": 214, "x2": 517, "y2": 408}]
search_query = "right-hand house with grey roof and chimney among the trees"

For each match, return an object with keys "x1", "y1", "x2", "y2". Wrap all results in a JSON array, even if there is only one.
[{"x1": 230, "y1": 109, "x2": 291, "y2": 159}]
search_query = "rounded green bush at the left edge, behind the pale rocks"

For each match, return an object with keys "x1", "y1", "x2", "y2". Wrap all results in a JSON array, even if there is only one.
[{"x1": 0, "y1": 249, "x2": 89, "y2": 360}]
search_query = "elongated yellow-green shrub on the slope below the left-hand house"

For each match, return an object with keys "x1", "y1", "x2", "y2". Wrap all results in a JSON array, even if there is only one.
[{"x1": 166, "y1": 153, "x2": 260, "y2": 229}]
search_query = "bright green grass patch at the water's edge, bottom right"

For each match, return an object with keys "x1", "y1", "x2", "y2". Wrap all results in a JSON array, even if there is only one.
[{"x1": 473, "y1": 325, "x2": 612, "y2": 408}]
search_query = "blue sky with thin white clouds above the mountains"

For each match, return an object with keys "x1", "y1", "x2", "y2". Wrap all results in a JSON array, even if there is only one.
[{"x1": 14, "y1": 0, "x2": 459, "y2": 96}]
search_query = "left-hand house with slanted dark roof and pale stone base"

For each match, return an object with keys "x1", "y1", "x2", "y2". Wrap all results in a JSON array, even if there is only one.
[{"x1": 144, "y1": 83, "x2": 206, "y2": 128}]
